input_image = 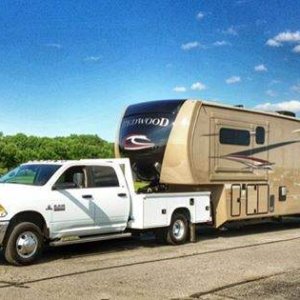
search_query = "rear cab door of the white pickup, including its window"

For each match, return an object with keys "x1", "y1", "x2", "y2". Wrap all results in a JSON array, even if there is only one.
[{"x1": 88, "y1": 165, "x2": 130, "y2": 233}]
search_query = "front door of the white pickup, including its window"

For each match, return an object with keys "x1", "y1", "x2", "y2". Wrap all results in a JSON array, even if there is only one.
[{"x1": 47, "y1": 166, "x2": 95, "y2": 236}]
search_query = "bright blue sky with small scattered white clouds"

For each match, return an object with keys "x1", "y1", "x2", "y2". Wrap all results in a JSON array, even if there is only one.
[{"x1": 0, "y1": 0, "x2": 300, "y2": 141}]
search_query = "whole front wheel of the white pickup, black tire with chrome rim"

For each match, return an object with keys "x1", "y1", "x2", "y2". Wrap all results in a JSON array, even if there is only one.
[{"x1": 4, "y1": 222, "x2": 44, "y2": 265}]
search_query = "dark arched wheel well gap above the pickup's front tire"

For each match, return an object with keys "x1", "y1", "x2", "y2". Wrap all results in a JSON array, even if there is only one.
[{"x1": 8, "y1": 211, "x2": 49, "y2": 238}]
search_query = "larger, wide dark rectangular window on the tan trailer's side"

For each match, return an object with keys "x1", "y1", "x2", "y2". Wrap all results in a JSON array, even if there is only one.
[{"x1": 219, "y1": 128, "x2": 250, "y2": 146}]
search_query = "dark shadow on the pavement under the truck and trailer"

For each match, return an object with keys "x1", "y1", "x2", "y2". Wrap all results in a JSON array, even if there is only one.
[{"x1": 0, "y1": 218, "x2": 300, "y2": 266}]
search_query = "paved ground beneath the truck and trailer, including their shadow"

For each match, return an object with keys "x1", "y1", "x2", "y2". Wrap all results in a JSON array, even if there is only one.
[{"x1": 0, "y1": 220, "x2": 300, "y2": 300}]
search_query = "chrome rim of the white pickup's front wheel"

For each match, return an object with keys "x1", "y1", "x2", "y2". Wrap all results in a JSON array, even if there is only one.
[{"x1": 16, "y1": 231, "x2": 39, "y2": 258}]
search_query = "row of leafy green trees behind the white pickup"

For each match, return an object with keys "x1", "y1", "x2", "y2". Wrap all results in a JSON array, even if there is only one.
[{"x1": 0, "y1": 132, "x2": 114, "y2": 173}]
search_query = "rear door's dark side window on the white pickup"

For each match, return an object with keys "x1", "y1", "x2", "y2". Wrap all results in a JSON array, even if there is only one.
[{"x1": 91, "y1": 166, "x2": 119, "y2": 187}]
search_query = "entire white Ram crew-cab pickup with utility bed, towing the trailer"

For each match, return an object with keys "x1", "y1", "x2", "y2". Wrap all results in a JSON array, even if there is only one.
[{"x1": 0, "y1": 159, "x2": 211, "y2": 265}]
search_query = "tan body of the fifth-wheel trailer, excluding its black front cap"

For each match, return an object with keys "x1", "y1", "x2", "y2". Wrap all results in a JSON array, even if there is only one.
[{"x1": 116, "y1": 100, "x2": 300, "y2": 227}]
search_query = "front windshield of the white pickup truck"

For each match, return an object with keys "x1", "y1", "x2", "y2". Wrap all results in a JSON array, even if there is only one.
[{"x1": 0, "y1": 164, "x2": 61, "y2": 186}]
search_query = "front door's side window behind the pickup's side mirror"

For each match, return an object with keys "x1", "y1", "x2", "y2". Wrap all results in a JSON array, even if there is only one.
[{"x1": 55, "y1": 166, "x2": 87, "y2": 188}]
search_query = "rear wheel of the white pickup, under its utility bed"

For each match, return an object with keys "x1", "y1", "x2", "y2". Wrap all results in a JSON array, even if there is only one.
[{"x1": 166, "y1": 213, "x2": 189, "y2": 245}]
